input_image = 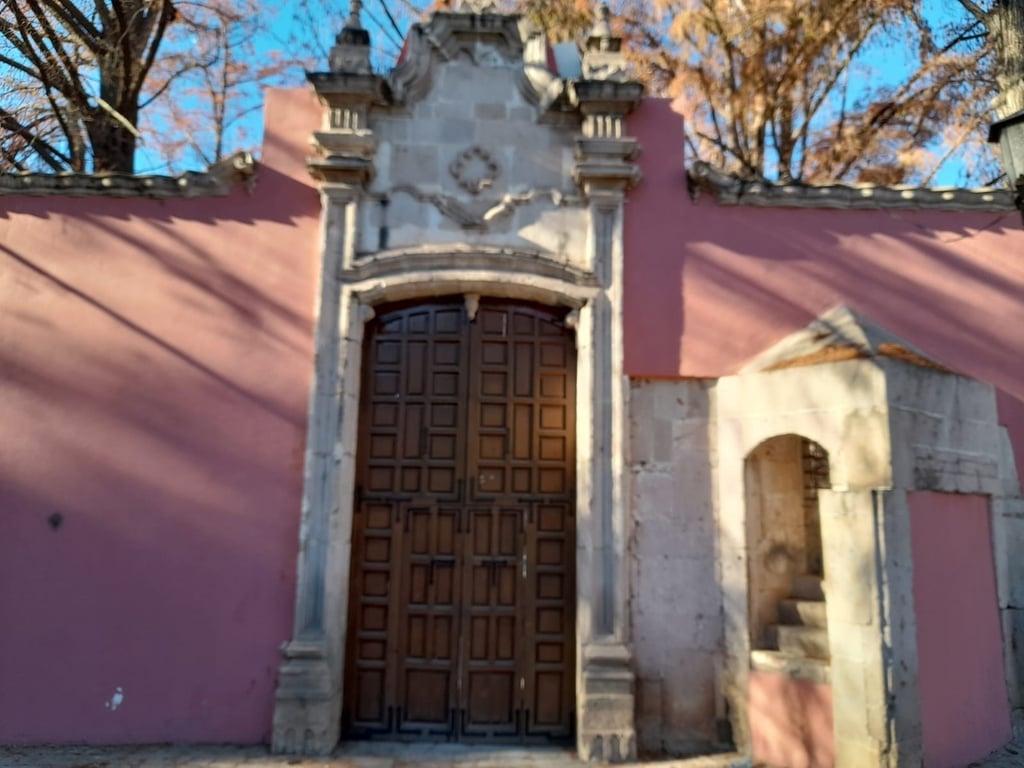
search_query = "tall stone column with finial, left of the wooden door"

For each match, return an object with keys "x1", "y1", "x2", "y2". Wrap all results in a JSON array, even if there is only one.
[{"x1": 272, "y1": 0, "x2": 383, "y2": 755}]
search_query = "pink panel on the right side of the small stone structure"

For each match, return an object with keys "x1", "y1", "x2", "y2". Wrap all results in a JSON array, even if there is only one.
[{"x1": 907, "y1": 493, "x2": 1011, "y2": 768}]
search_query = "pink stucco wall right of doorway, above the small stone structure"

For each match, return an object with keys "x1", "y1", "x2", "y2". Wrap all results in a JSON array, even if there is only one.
[{"x1": 625, "y1": 99, "x2": 1024, "y2": 474}]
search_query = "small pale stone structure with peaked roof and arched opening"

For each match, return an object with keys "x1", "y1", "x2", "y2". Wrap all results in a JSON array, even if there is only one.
[{"x1": 715, "y1": 307, "x2": 1020, "y2": 766}]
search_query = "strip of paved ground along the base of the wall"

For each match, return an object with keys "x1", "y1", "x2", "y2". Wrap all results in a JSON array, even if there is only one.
[{"x1": 0, "y1": 736, "x2": 1024, "y2": 768}]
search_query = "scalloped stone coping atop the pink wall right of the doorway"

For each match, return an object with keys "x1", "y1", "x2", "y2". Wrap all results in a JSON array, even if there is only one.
[{"x1": 687, "y1": 160, "x2": 1016, "y2": 213}]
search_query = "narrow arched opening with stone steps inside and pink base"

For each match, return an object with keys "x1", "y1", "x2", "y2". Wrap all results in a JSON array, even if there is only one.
[{"x1": 743, "y1": 434, "x2": 835, "y2": 766}]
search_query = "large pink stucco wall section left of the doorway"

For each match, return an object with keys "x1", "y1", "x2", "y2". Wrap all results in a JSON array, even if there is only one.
[{"x1": 0, "y1": 93, "x2": 318, "y2": 742}]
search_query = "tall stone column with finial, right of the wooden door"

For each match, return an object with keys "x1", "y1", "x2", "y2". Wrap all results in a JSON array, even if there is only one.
[{"x1": 569, "y1": 7, "x2": 642, "y2": 762}]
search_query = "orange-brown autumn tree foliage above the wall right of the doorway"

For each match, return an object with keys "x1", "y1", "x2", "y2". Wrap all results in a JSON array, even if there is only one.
[{"x1": 520, "y1": 0, "x2": 1024, "y2": 183}]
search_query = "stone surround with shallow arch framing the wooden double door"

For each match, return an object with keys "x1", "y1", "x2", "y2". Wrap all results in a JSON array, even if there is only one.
[{"x1": 274, "y1": 249, "x2": 635, "y2": 759}]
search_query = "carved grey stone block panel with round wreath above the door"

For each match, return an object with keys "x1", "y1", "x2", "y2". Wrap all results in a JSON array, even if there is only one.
[{"x1": 356, "y1": 58, "x2": 587, "y2": 267}]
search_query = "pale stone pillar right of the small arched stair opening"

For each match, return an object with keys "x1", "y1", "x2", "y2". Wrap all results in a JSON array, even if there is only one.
[{"x1": 818, "y1": 488, "x2": 922, "y2": 768}]
